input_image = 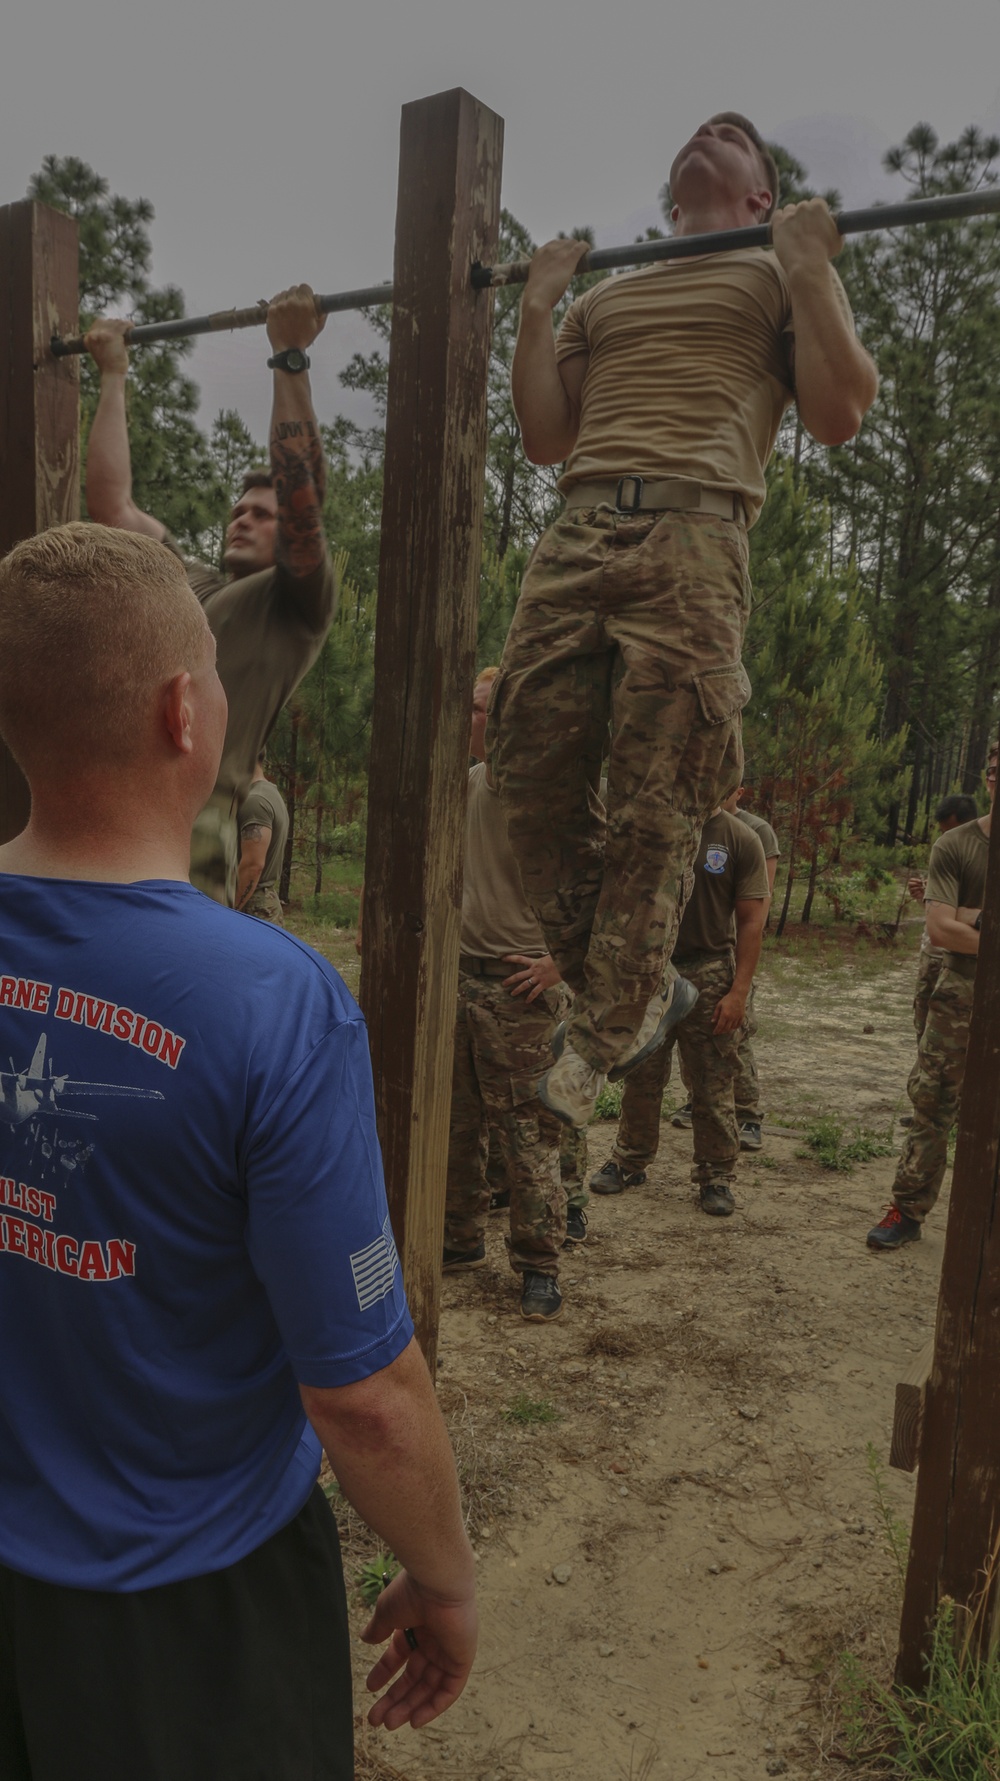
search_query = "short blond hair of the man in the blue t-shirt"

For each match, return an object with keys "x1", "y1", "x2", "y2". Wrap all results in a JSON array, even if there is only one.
[{"x1": 0, "y1": 520, "x2": 209, "y2": 778}]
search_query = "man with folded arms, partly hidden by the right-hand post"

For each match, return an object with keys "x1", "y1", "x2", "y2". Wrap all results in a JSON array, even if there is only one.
[{"x1": 868, "y1": 765, "x2": 996, "y2": 1250}]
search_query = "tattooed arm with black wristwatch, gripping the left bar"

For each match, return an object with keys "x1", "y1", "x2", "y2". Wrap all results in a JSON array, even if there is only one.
[{"x1": 267, "y1": 285, "x2": 330, "y2": 632}]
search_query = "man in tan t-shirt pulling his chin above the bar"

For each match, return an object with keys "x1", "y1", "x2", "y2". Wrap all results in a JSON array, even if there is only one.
[{"x1": 488, "y1": 112, "x2": 877, "y2": 1126}]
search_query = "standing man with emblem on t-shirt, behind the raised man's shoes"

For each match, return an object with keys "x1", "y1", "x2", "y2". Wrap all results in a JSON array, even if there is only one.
[{"x1": 590, "y1": 810, "x2": 768, "y2": 1218}]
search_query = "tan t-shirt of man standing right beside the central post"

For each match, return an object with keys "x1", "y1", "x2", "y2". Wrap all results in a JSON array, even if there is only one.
[{"x1": 462, "y1": 760, "x2": 545, "y2": 958}]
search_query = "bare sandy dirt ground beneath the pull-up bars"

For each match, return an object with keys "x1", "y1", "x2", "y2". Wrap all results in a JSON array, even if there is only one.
[{"x1": 324, "y1": 924, "x2": 945, "y2": 1781}]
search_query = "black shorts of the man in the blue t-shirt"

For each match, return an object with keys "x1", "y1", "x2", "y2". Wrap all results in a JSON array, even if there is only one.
[{"x1": 0, "y1": 1487, "x2": 355, "y2": 1781}]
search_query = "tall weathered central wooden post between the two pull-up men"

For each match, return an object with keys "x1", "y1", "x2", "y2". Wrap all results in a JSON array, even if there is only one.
[{"x1": 360, "y1": 89, "x2": 503, "y2": 1373}]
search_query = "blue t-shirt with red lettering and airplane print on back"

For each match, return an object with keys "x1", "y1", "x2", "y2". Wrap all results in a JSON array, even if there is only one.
[{"x1": 0, "y1": 876, "x2": 414, "y2": 1590}]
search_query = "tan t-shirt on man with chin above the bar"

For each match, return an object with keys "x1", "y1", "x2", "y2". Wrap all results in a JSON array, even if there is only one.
[{"x1": 556, "y1": 248, "x2": 850, "y2": 525}]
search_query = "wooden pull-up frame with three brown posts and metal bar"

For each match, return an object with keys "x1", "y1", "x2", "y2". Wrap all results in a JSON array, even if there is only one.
[{"x1": 0, "y1": 91, "x2": 1000, "y2": 1688}]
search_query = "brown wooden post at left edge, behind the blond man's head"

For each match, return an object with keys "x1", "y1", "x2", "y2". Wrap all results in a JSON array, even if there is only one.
[{"x1": 0, "y1": 198, "x2": 80, "y2": 842}]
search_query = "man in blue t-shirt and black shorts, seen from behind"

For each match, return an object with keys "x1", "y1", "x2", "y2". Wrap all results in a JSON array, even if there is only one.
[{"x1": 0, "y1": 525, "x2": 476, "y2": 1781}]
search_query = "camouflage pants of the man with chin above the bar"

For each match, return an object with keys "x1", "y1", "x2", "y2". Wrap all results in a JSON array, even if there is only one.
[{"x1": 487, "y1": 508, "x2": 750, "y2": 1069}]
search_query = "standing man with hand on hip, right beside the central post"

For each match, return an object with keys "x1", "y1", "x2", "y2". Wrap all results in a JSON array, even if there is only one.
[{"x1": 444, "y1": 671, "x2": 570, "y2": 1323}]
